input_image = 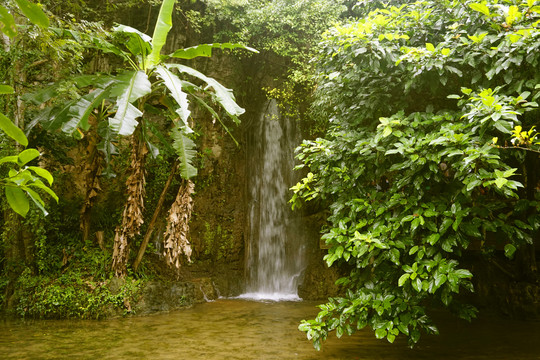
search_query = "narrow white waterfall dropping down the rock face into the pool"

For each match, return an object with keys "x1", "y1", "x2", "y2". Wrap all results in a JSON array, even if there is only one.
[{"x1": 241, "y1": 100, "x2": 305, "y2": 300}]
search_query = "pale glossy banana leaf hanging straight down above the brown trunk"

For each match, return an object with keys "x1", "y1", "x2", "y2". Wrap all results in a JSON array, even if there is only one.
[{"x1": 109, "y1": 71, "x2": 152, "y2": 135}]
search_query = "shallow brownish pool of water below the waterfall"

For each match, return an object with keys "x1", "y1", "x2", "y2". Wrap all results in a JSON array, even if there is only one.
[{"x1": 0, "y1": 299, "x2": 540, "y2": 360}]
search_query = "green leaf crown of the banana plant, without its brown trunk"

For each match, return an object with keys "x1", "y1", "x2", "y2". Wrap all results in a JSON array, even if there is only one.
[{"x1": 28, "y1": 0, "x2": 257, "y2": 179}]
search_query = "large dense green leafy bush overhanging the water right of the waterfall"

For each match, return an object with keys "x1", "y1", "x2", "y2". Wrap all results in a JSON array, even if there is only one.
[{"x1": 292, "y1": 0, "x2": 540, "y2": 348}]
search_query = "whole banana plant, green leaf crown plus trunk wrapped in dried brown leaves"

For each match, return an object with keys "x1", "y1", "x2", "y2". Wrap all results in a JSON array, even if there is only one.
[{"x1": 26, "y1": 0, "x2": 256, "y2": 276}]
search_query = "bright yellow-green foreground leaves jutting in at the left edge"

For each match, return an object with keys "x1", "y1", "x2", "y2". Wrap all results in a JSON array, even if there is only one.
[{"x1": 0, "y1": 0, "x2": 58, "y2": 217}]
